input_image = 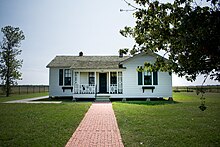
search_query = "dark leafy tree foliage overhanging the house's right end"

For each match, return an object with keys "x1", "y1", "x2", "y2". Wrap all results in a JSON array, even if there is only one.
[{"x1": 120, "y1": 0, "x2": 220, "y2": 81}]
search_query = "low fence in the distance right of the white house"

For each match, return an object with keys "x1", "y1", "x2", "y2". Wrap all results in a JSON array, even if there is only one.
[{"x1": 173, "y1": 85, "x2": 220, "y2": 93}]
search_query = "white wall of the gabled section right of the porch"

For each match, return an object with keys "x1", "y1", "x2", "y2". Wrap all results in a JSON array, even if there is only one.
[{"x1": 123, "y1": 55, "x2": 172, "y2": 98}]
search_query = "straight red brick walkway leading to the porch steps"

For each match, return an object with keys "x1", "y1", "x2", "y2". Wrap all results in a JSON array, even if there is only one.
[{"x1": 66, "y1": 103, "x2": 124, "y2": 147}]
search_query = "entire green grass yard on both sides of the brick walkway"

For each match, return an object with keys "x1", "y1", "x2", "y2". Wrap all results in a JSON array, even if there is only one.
[{"x1": 0, "y1": 93, "x2": 220, "y2": 147}]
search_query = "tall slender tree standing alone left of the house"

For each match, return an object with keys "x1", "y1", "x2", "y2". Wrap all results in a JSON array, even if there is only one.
[{"x1": 0, "y1": 26, "x2": 25, "y2": 97}]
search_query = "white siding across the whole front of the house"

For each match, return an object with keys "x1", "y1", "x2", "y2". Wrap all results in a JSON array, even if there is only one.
[{"x1": 49, "y1": 54, "x2": 172, "y2": 98}]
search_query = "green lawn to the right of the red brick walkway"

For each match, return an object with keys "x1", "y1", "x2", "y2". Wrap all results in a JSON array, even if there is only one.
[{"x1": 113, "y1": 93, "x2": 220, "y2": 146}]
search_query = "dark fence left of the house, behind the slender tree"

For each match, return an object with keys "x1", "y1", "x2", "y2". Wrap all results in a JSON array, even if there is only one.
[{"x1": 0, "y1": 85, "x2": 49, "y2": 94}]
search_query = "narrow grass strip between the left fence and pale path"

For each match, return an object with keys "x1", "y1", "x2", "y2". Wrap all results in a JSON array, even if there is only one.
[{"x1": 0, "y1": 92, "x2": 48, "y2": 102}]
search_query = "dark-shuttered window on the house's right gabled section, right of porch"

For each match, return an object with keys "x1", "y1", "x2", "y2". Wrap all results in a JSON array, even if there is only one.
[{"x1": 138, "y1": 71, "x2": 158, "y2": 85}]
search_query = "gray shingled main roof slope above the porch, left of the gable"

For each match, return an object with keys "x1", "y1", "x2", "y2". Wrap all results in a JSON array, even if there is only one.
[{"x1": 47, "y1": 56, "x2": 130, "y2": 69}]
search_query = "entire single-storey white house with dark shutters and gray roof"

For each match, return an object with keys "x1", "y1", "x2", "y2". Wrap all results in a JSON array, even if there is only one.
[{"x1": 47, "y1": 52, "x2": 172, "y2": 99}]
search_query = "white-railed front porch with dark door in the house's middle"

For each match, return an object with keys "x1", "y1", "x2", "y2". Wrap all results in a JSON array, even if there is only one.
[{"x1": 73, "y1": 71, "x2": 123, "y2": 97}]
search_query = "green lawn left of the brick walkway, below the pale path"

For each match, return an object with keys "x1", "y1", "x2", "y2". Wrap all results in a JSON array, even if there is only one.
[{"x1": 0, "y1": 103, "x2": 91, "y2": 147}]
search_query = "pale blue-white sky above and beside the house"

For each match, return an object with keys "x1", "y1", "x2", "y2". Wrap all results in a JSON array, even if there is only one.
[{"x1": 0, "y1": 0, "x2": 219, "y2": 86}]
